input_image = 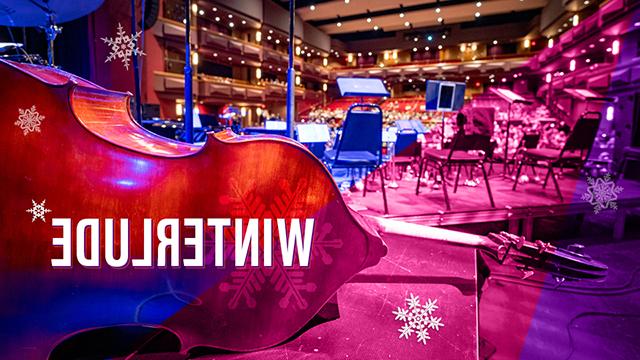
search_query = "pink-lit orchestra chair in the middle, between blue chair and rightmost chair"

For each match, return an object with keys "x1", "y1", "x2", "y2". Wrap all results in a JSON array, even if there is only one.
[{"x1": 416, "y1": 129, "x2": 496, "y2": 210}]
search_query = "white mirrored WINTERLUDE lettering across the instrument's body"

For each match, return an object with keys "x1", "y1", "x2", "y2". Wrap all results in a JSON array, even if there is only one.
[{"x1": 51, "y1": 218, "x2": 314, "y2": 269}]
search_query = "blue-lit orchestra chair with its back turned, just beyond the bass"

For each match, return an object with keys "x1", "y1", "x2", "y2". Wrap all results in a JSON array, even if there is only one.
[{"x1": 324, "y1": 103, "x2": 389, "y2": 214}]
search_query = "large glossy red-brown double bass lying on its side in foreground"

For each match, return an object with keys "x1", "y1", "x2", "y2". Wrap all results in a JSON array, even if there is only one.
[{"x1": 0, "y1": 60, "x2": 606, "y2": 359}]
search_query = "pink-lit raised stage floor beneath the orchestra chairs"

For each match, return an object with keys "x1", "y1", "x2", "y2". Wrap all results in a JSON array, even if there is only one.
[{"x1": 344, "y1": 173, "x2": 640, "y2": 226}]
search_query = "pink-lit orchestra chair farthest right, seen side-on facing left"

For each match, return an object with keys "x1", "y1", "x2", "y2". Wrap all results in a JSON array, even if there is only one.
[{"x1": 513, "y1": 112, "x2": 602, "y2": 202}]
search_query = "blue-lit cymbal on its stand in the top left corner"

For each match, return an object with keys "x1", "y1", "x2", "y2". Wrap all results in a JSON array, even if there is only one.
[{"x1": 0, "y1": 0, "x2": 104, "y2": 66}]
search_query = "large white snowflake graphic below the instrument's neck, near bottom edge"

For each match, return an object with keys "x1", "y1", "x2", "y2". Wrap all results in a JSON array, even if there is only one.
[{"x1": 392, "y1": 294, "x2": 444, "y2": 345}]
